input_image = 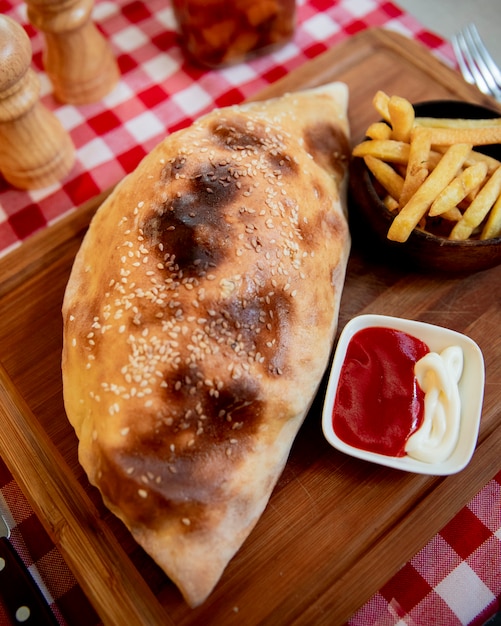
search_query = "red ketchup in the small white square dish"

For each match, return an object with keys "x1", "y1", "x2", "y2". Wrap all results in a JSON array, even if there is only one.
[{"x1": 332, "y1": 327, "x2": 430, "y2": 457}]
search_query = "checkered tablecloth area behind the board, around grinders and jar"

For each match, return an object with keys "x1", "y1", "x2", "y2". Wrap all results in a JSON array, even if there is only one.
[{"x1": 0, "y1": 0, "x2": 452, "y2": 255}]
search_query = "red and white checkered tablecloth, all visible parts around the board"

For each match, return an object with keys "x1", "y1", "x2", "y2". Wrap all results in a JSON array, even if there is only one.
[{"x1": 0, "y1": 0, "x2": 501, "y2": 626}]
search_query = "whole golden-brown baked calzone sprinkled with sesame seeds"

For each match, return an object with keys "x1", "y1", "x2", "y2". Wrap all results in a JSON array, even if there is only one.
[{"x1": 63, "y1": 85, "x2": 349, "y2": 606}]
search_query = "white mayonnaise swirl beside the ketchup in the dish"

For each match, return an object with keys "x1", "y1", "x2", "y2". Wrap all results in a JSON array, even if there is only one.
[{"x1": 405, "y1": 346, "x2": 463, "y2": 463}]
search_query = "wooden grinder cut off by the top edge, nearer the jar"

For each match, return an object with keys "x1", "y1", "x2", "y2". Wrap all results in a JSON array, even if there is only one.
[{"x1": 26, "y1": 0, "x2": 120, "y2": 104}]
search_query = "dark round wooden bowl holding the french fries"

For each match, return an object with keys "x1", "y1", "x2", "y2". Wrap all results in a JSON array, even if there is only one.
[{"x1": 350, "y1": 100, "x2": 501, "y2": 274}]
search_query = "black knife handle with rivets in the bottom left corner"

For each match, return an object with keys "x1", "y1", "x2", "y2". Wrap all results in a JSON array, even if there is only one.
[{"x1": 0, "y1": 537, "x2": 59, "y2": 626}]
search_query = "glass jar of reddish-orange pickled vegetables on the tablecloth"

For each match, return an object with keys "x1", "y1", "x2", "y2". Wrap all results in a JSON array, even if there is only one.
[{"x1": 172, "y1": 0, "x2": 296, "y2": 68}]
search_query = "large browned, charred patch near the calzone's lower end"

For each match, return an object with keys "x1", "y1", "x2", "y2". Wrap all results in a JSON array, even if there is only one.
[{"x1": 95, "y1": 369, "x2": 265, "y2": 532}]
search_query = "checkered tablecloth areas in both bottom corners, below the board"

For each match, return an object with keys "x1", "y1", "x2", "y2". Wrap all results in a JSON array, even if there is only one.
[{"x1": 0, "y1": 460, "x2": 501, "y2": 626}]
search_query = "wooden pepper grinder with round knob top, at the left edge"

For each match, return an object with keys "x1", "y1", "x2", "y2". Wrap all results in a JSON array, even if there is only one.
[{"x1": 0, "y1": 15, "x2": 75, "y2": 189}]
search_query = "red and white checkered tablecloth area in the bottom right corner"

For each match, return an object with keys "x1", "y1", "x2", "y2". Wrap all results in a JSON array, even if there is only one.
[{"x1": 349, "y1": 472, "x2": 501, "y2": 626}]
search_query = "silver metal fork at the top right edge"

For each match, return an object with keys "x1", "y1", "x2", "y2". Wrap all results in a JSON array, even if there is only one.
[{"x1": 452, "y1": 24, "x2": 501, "y2": 102}]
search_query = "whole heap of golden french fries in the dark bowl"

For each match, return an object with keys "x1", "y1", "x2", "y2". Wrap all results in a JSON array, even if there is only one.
[{"x1": 352, "y1": 91, "x2": 501, "y2": 242}]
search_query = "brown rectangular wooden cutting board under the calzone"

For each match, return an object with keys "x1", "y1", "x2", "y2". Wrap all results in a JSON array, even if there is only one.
[{"x1": 0, "y1": 30, "x2": 501, "y2": 626}]
